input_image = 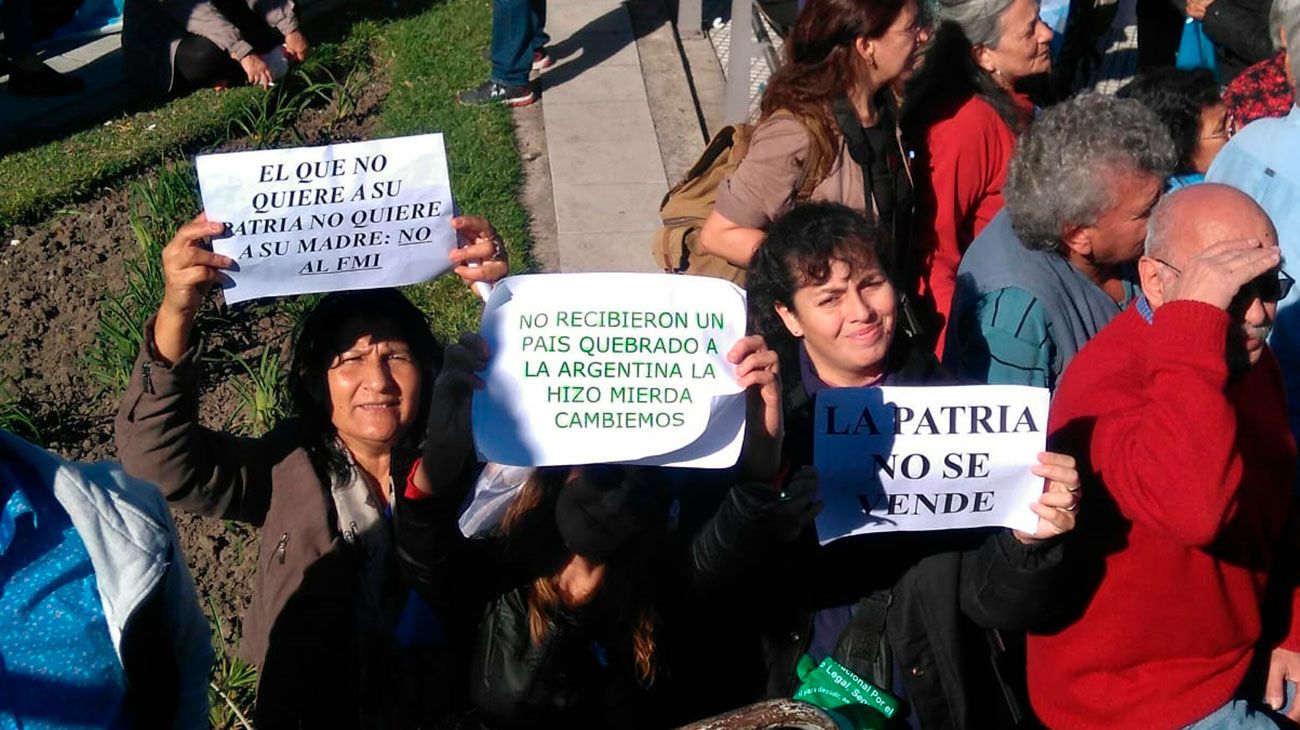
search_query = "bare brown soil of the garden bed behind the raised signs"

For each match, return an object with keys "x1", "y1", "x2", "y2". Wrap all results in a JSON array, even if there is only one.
[{"x1": 0, "y1": 72, "x2": 387, "y2": 649}]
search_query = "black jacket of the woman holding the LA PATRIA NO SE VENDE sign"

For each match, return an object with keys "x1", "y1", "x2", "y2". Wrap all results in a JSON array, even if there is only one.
[{"x1": 693, "y1": 339, "x2": 1063, "y2": 729}]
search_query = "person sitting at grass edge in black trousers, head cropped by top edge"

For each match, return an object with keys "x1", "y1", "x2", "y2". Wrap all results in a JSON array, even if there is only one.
[{"x1": 122, "y1": 0, "x2": 308, "y2": 95}]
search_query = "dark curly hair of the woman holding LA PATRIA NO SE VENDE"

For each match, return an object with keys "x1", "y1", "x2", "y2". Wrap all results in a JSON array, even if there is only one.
[{"x1": 746, "y1": 203, "x2": 892, "y2": 360}]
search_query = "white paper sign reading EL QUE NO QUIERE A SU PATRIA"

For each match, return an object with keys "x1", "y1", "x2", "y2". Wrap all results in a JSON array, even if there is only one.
[{"x1": 195, "y1": 134, "x2": 456, "y2": 304}]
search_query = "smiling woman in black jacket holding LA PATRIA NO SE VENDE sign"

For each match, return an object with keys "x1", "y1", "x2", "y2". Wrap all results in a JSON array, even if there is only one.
[{"x1": 715, "y1": 204, "x2": 1079, "y2": 727}]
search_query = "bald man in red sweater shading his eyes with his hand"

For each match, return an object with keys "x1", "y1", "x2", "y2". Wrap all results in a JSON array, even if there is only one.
[{"x1": 1028, "y1": 183, "x2": 1300, "y2": 729}]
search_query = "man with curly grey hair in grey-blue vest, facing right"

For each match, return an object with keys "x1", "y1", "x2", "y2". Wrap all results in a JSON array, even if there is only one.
[{"x1": 944, "y1": 94, "x2": 1178, "y2": 388}]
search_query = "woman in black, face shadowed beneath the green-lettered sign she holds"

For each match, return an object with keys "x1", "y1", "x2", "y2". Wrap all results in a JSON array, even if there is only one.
[{"x1": 397, "y1": 324, "x2": 780, "y2": 729}]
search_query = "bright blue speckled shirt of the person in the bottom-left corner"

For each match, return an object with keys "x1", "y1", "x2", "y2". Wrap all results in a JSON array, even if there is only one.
[{"x1": 0, "y1": 455, "x2": 126, "y2": 730}]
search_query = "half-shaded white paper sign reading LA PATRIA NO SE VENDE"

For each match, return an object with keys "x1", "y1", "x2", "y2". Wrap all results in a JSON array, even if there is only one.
[{"x1": 813, "y1": 386, "x2": 1048, "y2": 543}]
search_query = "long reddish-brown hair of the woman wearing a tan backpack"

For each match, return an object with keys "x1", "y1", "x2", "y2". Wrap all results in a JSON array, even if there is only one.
[{"x1": 761, "y1": 0, "x2": 907, "y2": 144}]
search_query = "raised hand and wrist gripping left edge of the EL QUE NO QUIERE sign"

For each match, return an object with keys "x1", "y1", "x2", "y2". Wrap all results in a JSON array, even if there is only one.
[{"x1": 153, "y1": 213, "x2": 235, "y2": 364}]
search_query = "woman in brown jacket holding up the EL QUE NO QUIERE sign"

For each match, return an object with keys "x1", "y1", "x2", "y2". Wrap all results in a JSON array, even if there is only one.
[{"x1": 116, "y1": 214, "x2": 507, "y2": 727}]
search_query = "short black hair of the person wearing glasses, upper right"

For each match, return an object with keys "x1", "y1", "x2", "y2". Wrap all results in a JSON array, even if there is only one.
[{"x1": 1115, "y1": 68, "x2": 1223, "y2": 174}]
